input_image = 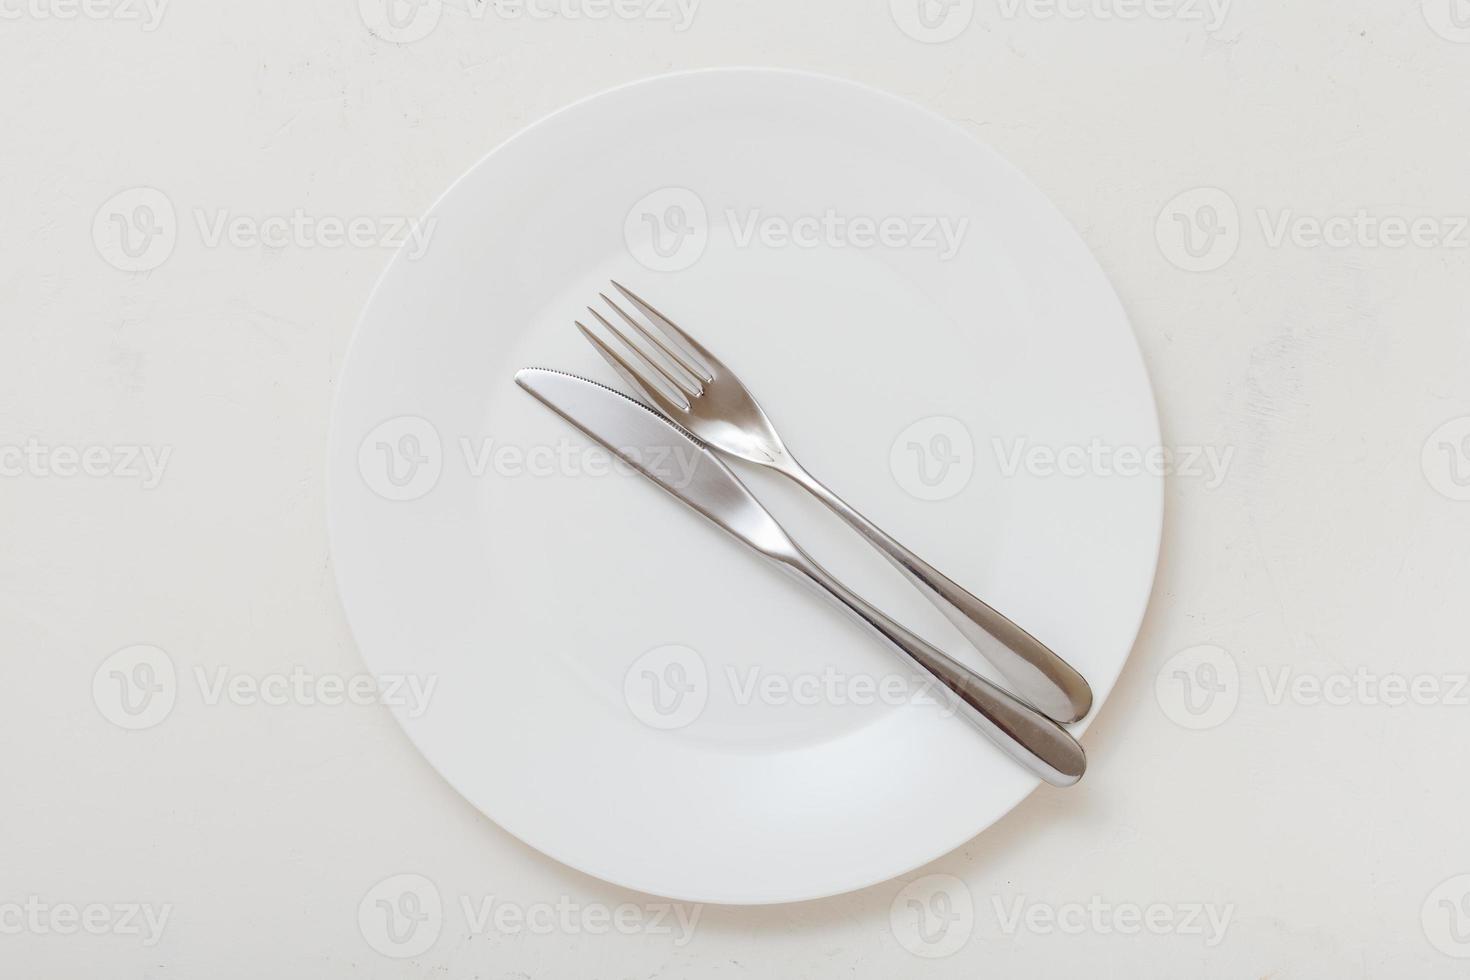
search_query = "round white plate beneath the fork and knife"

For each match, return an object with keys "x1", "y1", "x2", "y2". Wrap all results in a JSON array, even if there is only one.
[{"x1": 329, "y1": 69, "x2": 1161, "y2": 904}]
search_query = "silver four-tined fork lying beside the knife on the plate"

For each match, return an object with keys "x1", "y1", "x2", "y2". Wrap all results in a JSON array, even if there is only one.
[{"x1": 576, "y1": 281, "x2": 1092, "y2": 723}]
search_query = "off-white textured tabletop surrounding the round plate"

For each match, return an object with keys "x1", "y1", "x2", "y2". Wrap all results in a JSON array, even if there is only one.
[{"x1": 0, "y1": 0, "x2": 1470, "y2": 980}]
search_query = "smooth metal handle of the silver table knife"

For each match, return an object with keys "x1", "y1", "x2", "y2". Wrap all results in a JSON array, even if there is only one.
[{"x1": 778, "y1": 548, "x2": 1088, "y2": 786}]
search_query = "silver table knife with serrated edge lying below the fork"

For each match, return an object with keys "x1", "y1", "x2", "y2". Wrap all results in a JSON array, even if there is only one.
[{"x1": 516, "y1": 367, "x2": 1088, "y2": 786}]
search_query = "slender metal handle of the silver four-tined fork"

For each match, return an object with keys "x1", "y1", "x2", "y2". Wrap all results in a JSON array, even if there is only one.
[{"x1": 773, "y1": 455, "x2": 1092, "y2": 723}]
